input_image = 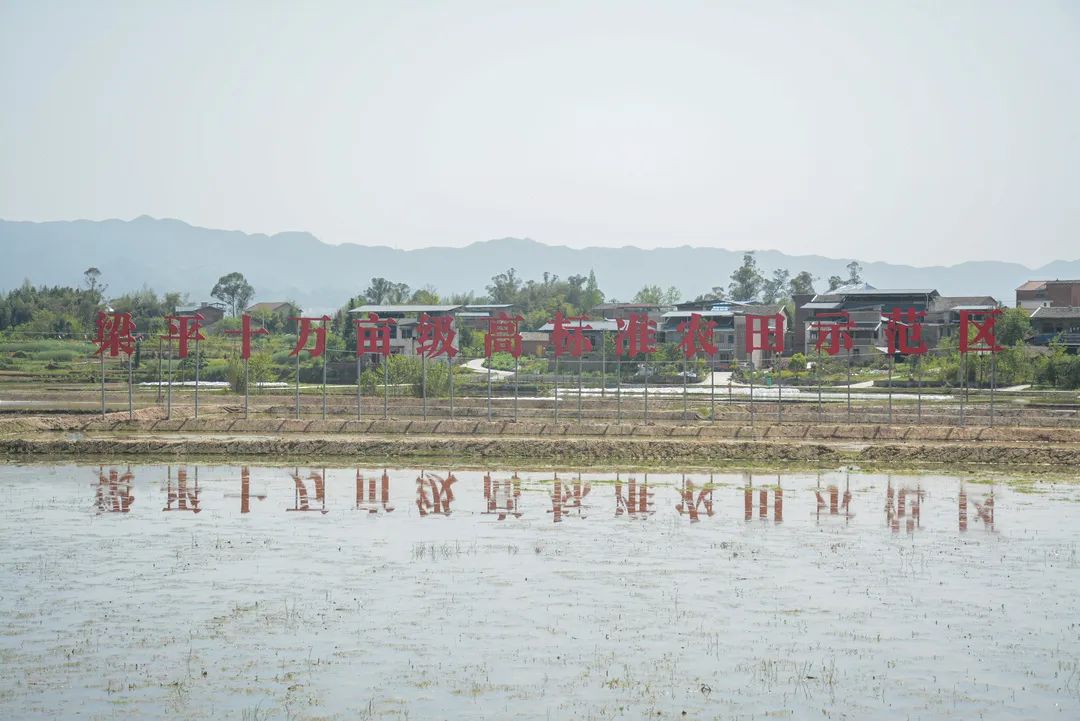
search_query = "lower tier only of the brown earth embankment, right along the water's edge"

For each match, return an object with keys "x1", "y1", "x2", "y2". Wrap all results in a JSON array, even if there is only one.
[{"x1": 0, "y1": 434, "x2": 1080, "y2": 470}]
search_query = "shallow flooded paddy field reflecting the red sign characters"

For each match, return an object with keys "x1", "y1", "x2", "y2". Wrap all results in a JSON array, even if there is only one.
[{"x1": 0, "y1": 463, "x2": 1080, "y2": 720}]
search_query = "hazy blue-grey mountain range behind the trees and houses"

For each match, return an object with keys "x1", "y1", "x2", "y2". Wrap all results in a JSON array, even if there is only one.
[{"x1": 0, "y1": 216, "x2": 1080, "y2": 311}]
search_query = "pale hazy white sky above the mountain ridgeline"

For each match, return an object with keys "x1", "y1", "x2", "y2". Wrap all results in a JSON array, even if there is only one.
[{"x1": 0, "y1": 0, "x2": 1080, "y2": 264}]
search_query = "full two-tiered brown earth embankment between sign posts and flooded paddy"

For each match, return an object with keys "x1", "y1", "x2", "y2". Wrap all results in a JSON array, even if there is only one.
[{"x1": 0, "y1": 410, "x2": 1080, "y2": 472}]
